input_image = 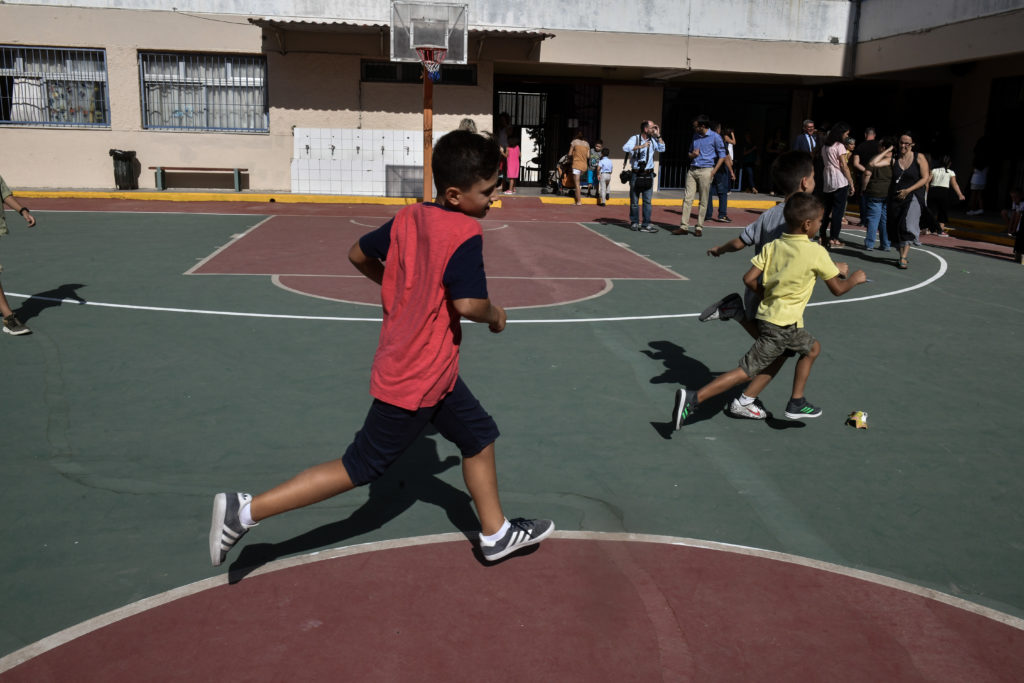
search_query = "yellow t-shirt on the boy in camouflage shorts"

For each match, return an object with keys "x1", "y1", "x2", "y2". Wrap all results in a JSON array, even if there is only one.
[{"x1": 751, "y1": 232, "x2": 839, "y2": 328}]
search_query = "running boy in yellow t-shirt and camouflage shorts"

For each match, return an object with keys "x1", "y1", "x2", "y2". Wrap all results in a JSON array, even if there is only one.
[{"x1": 672, "y1": 193, "x2": 866, "y2": 429}]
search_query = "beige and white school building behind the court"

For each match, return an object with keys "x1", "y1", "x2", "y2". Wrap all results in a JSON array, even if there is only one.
[{"x1": 0, "y1": 0, "x2": 1024, "y2": 203}]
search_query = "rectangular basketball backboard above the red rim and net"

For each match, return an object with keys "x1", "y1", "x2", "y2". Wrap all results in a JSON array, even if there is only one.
[{"x1": 391, "y1": 2, "x2": 469, "y2": 65}]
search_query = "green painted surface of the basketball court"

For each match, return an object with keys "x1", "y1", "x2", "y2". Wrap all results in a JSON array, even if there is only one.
[{"x1": 0, "y1": 207, "x2": 1024, "y2": 657}]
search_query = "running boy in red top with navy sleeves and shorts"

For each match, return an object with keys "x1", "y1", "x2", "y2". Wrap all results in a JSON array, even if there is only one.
[{"x1": 210, "y1": 130, "x2": 554, "y2": 566}]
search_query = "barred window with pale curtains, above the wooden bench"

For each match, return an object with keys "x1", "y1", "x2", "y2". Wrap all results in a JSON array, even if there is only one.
[{"x1": 138, "y1": 52, "x2": 269, "y2": 133}]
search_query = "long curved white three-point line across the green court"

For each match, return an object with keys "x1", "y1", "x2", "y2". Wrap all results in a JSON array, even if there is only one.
[{"x1": 7, "y1": 247, "x2": 949, "y2": 325}]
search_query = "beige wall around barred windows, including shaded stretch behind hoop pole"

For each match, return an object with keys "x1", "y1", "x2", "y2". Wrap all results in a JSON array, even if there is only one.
[{"x1": 0, "y1": 5, "x2": 494, "y2": 191}]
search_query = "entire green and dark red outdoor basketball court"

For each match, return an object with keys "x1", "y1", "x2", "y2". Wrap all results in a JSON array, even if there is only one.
[{"x1": 0, "y1": 193, "x2": 1024, "y2": 682}]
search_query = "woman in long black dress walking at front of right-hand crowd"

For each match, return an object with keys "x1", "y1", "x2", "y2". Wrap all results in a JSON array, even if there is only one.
[{"x1": 870, "y1": 132, "x2": 932, "y2": 269}]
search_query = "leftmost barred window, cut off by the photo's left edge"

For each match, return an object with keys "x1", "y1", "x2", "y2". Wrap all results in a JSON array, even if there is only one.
[{"x1": 0, "y1": 45, "x2": 111, "y2": 127}]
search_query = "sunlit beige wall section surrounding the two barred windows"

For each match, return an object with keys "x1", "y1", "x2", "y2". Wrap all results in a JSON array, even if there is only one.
[{"x1": 0, "y1": 5, "x2": 272, "y2": 188}]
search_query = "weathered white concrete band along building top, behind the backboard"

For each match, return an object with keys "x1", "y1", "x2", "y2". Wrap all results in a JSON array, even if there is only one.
[{"x1": 5, "y1": 0, "x2": 856, "y2": 43}]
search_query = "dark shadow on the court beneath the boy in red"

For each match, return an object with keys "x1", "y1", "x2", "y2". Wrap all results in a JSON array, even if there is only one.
[{"x1": 227, "y1": 436, "x2": 481, "y2": 584}]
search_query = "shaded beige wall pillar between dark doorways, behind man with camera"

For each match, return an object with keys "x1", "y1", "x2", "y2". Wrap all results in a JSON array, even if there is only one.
[{"x1": 601, "y1": 85, "x2": 663, "y2": 191}]
